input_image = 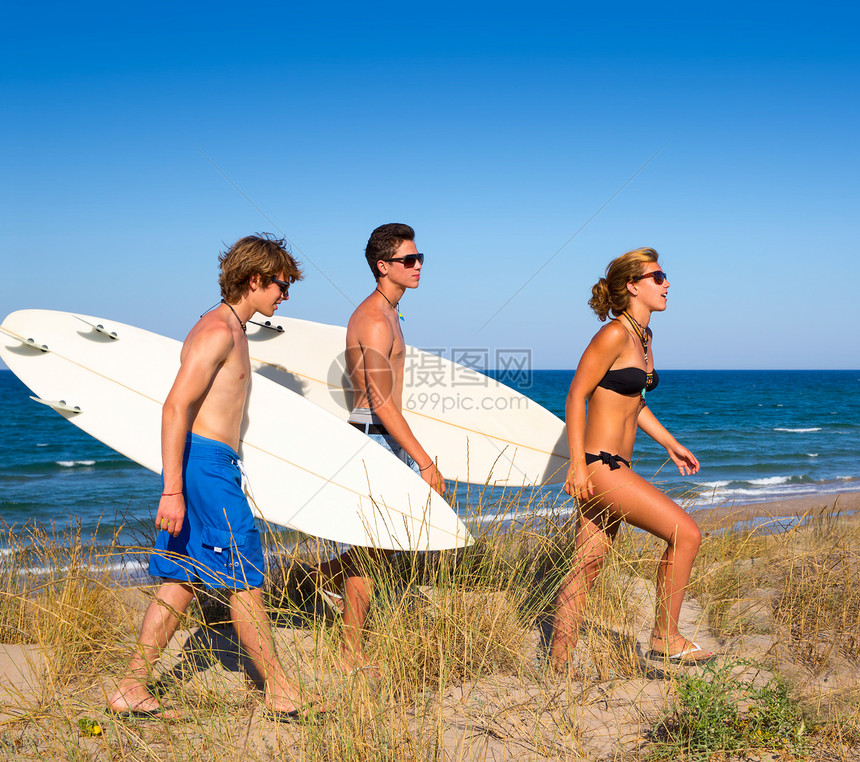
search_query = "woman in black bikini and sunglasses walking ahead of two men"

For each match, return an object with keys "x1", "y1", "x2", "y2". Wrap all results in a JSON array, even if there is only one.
[{"x1": 550, "y1": 248, "x2": 713, "y2": 671}]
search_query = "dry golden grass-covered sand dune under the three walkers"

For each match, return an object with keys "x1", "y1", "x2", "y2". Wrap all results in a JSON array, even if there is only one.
[{"x1": 0, "y1": 493, "x2": 860, "y2": 762}]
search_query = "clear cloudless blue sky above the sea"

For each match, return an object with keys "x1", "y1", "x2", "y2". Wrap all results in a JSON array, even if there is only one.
[{"x1": 0, "y1": 2, "x2": 860, "y2": 368}]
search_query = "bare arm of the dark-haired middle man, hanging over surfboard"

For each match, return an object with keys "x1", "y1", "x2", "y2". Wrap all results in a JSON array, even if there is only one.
[{"x1": 359, "y1": 322, "x2": 445, "y2": 495}]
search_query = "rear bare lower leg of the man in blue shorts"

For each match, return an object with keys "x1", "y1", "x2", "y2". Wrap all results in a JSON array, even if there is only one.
[{"x1": 108, "y1": 582, "x2": 194, "y2": 712}]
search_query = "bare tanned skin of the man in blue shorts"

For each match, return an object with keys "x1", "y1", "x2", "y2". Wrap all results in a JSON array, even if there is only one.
[{"x1": 108, "y1": 274, "x2": 318, "y2": 716}]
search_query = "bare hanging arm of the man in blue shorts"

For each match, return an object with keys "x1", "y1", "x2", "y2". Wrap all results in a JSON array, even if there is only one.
[{"x1": 155, "y1": 322, "x2": 233, "y2": 537}]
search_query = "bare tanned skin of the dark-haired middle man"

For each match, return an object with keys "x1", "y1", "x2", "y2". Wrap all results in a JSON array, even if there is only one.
[{"x1": 319, "y1": 241, "x2": 445, "y2": 671}]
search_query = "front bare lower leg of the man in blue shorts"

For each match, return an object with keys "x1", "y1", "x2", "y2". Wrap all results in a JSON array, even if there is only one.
[{"x1": 230, "y1": 588, "x2": 301, "y2": 712}]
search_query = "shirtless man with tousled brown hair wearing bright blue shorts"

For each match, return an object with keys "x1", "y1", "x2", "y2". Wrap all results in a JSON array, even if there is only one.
[{"x1": 108, "y1": 236, "x2": 316, "y2": 719}]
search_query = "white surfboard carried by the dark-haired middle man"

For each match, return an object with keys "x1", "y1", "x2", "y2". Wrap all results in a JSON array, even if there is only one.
[{"x1": 242, "y1": 317, "x2": 569, "y2": 480}]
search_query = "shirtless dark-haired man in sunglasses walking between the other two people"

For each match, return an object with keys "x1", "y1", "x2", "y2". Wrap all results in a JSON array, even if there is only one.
[{"x1": 320, "y1": 223, "x2": 445, "y2": 670}]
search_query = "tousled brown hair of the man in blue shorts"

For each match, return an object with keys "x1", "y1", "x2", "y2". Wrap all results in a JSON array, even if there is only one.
[{"x1": 218, "y1": 233, "x2": 302, "y2": 304}]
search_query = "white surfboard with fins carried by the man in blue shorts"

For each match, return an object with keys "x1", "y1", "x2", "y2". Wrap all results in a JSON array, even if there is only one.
[{"x1": 0, "y1": 310, "x2": 472, "y2": 550}]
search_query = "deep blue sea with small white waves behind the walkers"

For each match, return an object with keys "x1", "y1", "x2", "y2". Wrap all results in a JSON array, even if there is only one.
[{"x1": 0, "y1": 370, "x2": 860, "y2": 543}]
